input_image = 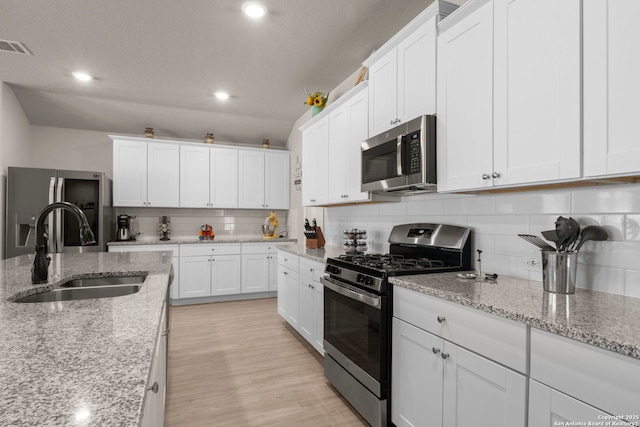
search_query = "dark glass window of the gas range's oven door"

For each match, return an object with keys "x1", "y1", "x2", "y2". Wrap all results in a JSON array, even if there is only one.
[{"x1": 324, "y1": 287, "x2": 387, "y2": 383}]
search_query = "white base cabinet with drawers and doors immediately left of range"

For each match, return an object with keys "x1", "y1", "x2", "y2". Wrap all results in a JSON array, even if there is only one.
[{"x1": 278, "y1": 251, "x2": 324, "y2": 355}]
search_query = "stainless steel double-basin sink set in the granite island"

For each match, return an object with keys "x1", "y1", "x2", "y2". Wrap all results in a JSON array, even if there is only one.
[{"x1": 14, "y1": 275, "x2": 146, "y2": 303}]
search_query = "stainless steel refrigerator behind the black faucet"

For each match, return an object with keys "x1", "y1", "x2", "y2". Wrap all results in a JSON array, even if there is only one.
[{"x1": 5, "y1": 167, "x2": 113, "y2": 258}]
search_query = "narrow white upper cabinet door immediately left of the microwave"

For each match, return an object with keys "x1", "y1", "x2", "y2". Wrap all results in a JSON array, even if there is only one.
[{"x1": 344, "y1": 90, "x2": 369, "y2": 202}]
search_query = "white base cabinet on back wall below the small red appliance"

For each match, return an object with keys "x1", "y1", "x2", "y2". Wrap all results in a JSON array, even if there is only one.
[{"x1": 179, "y1": 243, "x2": 241, "y2": 299}]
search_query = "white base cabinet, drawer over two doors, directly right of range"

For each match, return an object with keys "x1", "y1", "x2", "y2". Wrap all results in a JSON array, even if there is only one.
[{"x1": 391, "y1": 288, "x2": 527, "y2": 427}]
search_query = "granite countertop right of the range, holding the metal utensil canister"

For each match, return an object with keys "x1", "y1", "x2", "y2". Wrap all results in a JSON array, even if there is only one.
[{"x1": 389, "y1": 273, "x2": 640, "y2": 359}]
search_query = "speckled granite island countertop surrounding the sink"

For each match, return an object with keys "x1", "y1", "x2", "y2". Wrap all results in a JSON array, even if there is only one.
[{"x1": 0, "y1": 251, "x2": 172, "y2": 426}]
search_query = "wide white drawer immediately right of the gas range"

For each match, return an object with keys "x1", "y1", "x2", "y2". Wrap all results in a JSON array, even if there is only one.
[{"x1": 393, "y1": 286, "x2": 527, "y2": 373}]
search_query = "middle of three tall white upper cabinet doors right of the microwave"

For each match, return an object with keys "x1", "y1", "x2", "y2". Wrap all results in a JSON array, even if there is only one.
[{"x1": 492, "y1": 0, "x2": 584, "y2": 185}]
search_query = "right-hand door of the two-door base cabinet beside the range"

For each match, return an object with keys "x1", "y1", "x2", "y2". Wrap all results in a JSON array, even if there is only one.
[{"x1": 442, "y1": 341, "x2": 527, "y2": 427}]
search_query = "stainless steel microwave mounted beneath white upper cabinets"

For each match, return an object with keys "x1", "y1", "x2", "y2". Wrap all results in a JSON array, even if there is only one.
[{"x1": 361, "y1": 116, "x2": 437, "y2": 192}]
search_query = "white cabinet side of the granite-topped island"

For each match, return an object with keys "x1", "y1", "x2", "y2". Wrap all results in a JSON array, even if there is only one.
[{"x1": 140, "y1": 302, "x2": 168, "y2": 427}]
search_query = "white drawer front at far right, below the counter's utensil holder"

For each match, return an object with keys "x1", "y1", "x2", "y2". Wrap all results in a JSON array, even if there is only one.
[{"x1": 531, "y1": 328, "x2": 640, "y2": 421}]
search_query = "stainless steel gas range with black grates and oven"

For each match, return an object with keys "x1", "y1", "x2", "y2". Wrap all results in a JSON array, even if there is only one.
[{"x1": 321, "y1": 223, "x2": 471, "y2": 427}]
